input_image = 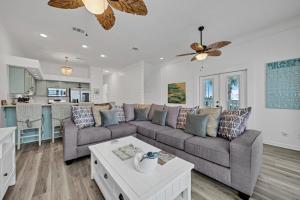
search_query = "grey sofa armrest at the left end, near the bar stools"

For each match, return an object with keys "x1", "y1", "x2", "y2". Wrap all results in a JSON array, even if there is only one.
[{"x1": 63, "y1": 119, "x2": 78, "y2": 161}]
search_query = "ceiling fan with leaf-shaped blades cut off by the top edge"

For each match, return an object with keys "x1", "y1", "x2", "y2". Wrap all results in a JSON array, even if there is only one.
[{"x1": 48, "y1": 0, "x2": 148, "y2": 30}]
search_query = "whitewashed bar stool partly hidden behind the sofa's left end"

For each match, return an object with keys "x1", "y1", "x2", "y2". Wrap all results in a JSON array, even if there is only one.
[{"x1": 51, "y1": 103, "x2": 71, "y2": 143}]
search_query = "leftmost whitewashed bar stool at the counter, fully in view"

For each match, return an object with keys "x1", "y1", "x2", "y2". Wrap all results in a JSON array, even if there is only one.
[{"x1": 16, "y1": 103, "x2": 42, "y2": 149}]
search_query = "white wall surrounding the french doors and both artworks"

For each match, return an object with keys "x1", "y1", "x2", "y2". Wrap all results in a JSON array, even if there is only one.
[{"x1": 155, "y1": 20, "x2": 300, "y2": 150}]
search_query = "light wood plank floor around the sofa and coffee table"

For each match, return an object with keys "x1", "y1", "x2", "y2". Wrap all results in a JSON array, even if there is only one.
[{"x1": 4, "y1": 141, "x2": 300, "y2": 200}]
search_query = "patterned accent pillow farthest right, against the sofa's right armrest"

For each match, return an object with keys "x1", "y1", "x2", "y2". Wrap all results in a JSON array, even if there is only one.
[{"x1": 218, "y1": 108, "x2": 251, "y2": 140}]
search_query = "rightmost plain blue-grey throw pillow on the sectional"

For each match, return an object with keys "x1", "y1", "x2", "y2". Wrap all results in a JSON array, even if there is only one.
[{"x1": 184, "y1": 114, "x2": 208, "y2": 137}]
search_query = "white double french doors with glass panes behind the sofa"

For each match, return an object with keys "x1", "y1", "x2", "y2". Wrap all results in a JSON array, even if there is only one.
[{"x1": 199, "y1": 70, "x2": 247, "y2": 110}]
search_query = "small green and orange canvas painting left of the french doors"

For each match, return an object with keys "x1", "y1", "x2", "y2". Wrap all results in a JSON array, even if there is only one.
[{"x1": 168, "y1": 83, "x2": 186, "y2": 104}]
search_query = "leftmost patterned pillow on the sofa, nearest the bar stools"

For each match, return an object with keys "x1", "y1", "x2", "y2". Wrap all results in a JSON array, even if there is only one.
[{"x1": 72, "y1": 106, "x2": 95, "y2": 129}]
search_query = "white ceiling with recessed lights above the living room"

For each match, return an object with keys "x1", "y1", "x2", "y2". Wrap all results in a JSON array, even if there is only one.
[{"x1": 0, "y1": 0, "x2": 300, "y2": 68}]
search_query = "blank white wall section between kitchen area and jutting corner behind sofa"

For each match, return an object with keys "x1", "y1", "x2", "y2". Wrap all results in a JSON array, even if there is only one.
[{"x1": 105, "y1": 62, "x2": 144, "y2": 105}]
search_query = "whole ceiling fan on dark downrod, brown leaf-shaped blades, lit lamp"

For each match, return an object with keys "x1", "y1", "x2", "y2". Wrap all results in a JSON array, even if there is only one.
[{"x1": 177, "y1": 26, "x2": 231, "y2": 61}]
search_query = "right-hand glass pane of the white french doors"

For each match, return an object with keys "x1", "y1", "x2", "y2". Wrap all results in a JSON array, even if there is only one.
[{"x1": 227, "y1": 75, "x2": 240, "y2": 110}]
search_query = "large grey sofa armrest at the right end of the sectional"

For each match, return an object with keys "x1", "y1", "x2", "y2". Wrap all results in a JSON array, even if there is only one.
[{"x1": 230, "y1": 130, "x2": 263, "y2": 196}]
